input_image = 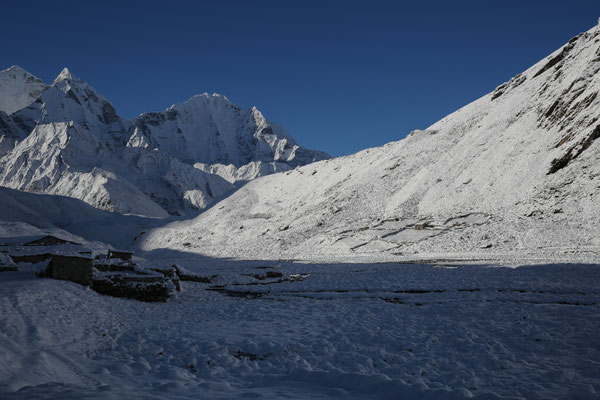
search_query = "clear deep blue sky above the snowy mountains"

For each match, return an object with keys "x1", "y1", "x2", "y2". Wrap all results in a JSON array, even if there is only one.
[{"x1": 0, "y1": 0, "x2": 600, "y2": 156}]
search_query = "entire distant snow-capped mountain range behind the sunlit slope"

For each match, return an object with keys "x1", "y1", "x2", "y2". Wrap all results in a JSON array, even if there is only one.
[{"x1": 0, "y1": 67, "x2": 329, "y2": 217}]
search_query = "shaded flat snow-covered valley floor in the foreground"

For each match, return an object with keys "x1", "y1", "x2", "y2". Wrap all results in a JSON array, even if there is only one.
[{"x1": 0, "y1": 255, "x2": 600, "y2": 399}]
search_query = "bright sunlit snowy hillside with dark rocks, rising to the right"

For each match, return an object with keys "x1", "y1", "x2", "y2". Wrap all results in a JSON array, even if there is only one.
[{"x1": 143, "y1": 22, "x2": 600, "y2": 258}]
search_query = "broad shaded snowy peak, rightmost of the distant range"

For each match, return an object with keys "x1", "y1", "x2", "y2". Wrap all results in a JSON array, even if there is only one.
[{"x1": 128, "y1": 93, "x2": 330, "y2": 168}]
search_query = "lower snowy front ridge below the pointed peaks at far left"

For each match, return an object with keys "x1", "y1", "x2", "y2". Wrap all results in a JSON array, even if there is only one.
[{"x1": 0, "y1": 122, "x2": 231, "y2": 217}]
